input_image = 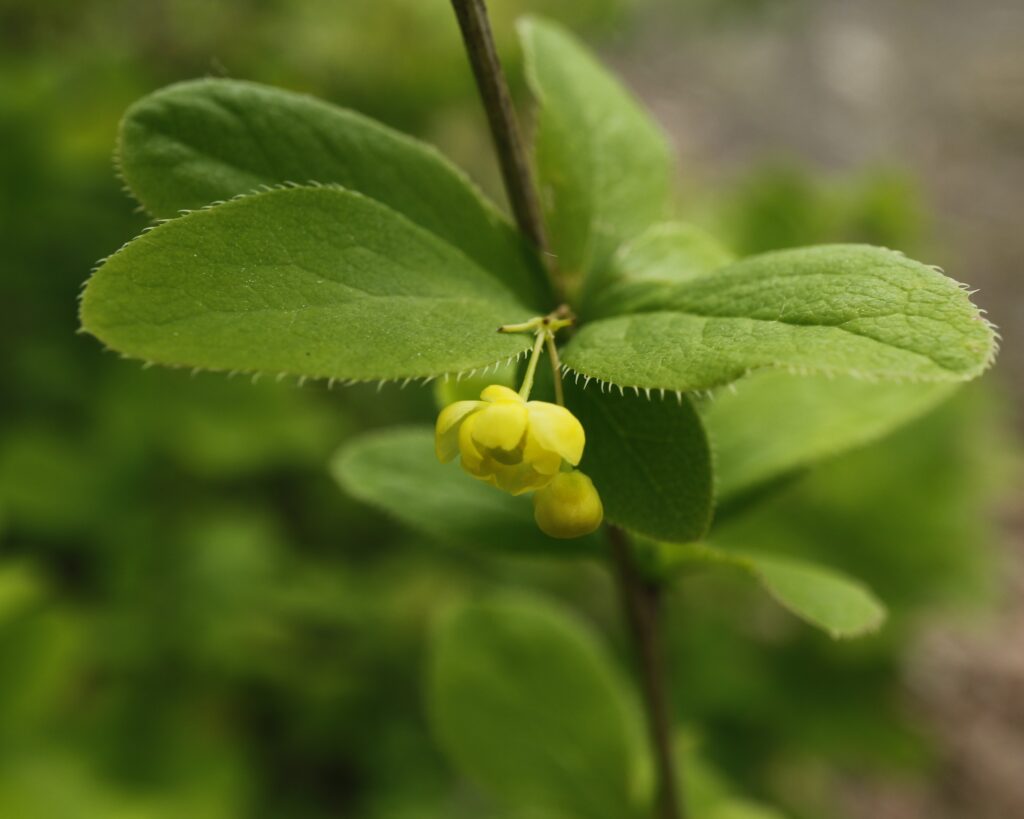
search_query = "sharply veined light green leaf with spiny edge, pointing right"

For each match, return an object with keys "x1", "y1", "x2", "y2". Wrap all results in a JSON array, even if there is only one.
[{"x1": 563, "y1": 245, "x2": 994, "y2": 390}]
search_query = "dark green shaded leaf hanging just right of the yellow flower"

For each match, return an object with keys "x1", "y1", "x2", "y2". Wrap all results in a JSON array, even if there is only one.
[{"x1": 565, "y1": 381, "x2": 714, "y2": 543}]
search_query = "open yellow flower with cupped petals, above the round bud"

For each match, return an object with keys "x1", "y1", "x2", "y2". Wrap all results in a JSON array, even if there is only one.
[{"x1": 435, "y1": 384, "x2": 585, "y2": 494}]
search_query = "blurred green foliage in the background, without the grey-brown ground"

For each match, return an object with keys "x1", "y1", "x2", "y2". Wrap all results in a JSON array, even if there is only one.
[{"x1": 0, "y1": 0, "x2": 1016, "y2": 819}]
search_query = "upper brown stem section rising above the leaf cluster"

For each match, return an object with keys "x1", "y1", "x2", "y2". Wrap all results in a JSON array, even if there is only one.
[{"x1": 452, "y1": 0, "x2": 563, "y2": 299}]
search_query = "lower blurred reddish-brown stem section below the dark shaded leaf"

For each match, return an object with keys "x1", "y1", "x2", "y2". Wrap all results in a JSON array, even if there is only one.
[{"x1": 608, "y1": 525, "x2": 686, "y2": 819}]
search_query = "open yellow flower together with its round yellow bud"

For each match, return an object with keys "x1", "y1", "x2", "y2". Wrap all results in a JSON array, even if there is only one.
[{"x1": 435, "y1": 384, "x2": 603, "y2": 537}]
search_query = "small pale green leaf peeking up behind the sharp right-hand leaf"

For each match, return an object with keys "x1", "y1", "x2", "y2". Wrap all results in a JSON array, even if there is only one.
[{"x1": 581, "y1": 222, "x2": 735, "y2": 319}]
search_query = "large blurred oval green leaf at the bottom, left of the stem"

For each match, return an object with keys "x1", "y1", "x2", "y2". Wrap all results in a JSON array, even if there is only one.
[{"x1": 429, "y1": 596, "x2": 650, "y2": 819}]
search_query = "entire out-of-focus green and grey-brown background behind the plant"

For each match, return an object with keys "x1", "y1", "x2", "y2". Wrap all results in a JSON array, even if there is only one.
[{"x1": 0, "y1": 0, "x2": 1024, "y2": 819}]
